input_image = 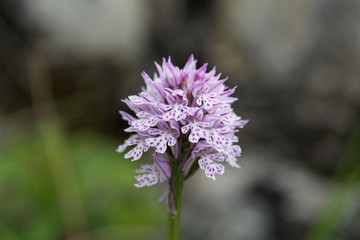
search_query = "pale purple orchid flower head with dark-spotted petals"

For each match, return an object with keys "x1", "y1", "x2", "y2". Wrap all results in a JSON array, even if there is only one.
[{"x1": 117, "y1": 55, "x2": 248, "y2": 191}]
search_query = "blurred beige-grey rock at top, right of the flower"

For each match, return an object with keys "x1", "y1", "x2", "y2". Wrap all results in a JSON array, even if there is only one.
[{"x1": 219, "y1": 0, "x2": 321, "y2": 78}]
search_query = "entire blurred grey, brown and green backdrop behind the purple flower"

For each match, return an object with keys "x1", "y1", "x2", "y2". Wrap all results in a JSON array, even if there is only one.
[{"x1": 0, "y1": 0, "x2": 360, "y2": 240}]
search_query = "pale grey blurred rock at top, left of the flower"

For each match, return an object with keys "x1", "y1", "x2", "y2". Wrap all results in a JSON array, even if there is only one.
[{"x1": 23, "y1": 0, "x2": 151, "y2": 62}]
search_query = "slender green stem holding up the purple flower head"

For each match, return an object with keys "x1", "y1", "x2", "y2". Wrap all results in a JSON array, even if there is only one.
[{"x1": 167, "y1": 167, "x2": 184, "y2": 240}]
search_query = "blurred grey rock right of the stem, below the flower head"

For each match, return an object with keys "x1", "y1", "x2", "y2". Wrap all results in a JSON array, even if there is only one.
[{"x1": 183, "y1": 150, "x2": 332, "y2": 240}]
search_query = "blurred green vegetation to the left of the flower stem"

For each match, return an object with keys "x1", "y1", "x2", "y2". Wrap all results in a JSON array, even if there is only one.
[{"x1": 0, "y1": 123, "x2": 166, "y2": 240}]
